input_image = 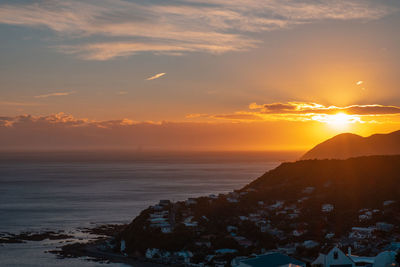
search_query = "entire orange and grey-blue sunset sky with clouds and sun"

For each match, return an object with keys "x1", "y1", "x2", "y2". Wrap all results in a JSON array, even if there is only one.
[{"x1": 0, "y1": 0, "x2": 400, "y2": 150}]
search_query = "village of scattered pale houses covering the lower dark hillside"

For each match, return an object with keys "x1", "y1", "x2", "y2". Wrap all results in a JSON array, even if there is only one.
[{"x1": 120, "y1": 179, "x2": 400, "y2": 267}]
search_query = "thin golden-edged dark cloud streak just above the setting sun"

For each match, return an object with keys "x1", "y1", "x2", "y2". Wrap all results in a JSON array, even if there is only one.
[{"x1": 187, "y1": 102, "x2": 400, "y2": 122}]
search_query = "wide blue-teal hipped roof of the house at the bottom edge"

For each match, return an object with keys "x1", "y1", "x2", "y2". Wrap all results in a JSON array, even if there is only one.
[{"x1": 232, "y1": 252, "x2": 306, "y2": 267}]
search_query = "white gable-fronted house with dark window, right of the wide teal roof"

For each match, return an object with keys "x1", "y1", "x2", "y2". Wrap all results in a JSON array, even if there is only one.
[{"x1": 311, "y1": 247, "x2": 356, "y2": 267}]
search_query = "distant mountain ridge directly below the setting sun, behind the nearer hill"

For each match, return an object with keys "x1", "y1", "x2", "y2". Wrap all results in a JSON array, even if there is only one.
[{"x1": 301, "y1": 131, "x2": 400, "y2": 160}]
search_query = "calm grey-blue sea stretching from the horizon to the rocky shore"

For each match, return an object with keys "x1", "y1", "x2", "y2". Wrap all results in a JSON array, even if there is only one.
[{"x1": 0, "y1": 150, "x2": 300, "y2": 267}]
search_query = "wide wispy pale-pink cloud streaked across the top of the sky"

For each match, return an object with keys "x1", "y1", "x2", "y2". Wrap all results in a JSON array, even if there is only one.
[{"x1": 0, "y1": 0, "x2": 394, "y2": 60}]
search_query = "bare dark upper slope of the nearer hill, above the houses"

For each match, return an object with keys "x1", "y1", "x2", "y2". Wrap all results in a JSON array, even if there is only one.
[{"x1": 245, "y1": 155, "x2": 400, "y2": 203}]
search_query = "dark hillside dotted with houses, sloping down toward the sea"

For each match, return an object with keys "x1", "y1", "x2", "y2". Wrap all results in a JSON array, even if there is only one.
[{"x1": 119, "y1": 156, "x2": 400, "y2": 263}]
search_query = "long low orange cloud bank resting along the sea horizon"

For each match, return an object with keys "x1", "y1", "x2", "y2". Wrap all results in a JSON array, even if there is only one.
[{"x1": 0, "y1": 111, "x2": 400, "y2": 151}]
